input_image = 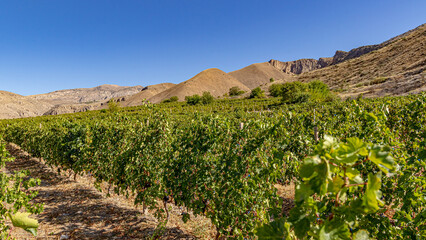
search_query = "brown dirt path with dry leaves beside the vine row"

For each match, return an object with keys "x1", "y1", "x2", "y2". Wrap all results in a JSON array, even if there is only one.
[{"x1": 6, "y1": 144, "x2": 201, "y2": 240}]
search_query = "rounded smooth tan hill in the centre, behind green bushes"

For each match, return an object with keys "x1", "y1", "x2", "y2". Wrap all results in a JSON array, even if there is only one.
[{"x1": 148, "y1": 68, "x2": 250, "y2": 103}]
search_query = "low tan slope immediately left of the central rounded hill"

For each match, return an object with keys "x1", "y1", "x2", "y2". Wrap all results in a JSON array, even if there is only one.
[{"x1": 120, "y1": 83, "x2": 176, "y2": 107}]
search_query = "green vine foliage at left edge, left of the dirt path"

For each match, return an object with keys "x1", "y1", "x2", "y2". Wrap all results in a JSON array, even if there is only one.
[{"x1": 0, "y1": 139, "x2": 43, "y2": 239}]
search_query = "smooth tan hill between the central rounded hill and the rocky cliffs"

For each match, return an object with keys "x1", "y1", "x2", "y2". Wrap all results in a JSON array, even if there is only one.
[{"x1": 228, "y1": 62, "x2": 292, "y2": 89}]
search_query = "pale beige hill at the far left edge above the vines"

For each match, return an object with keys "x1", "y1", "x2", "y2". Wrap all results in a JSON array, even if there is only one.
[{"x1": 0, "y1": 91, "x2": 52, "y2": 119}]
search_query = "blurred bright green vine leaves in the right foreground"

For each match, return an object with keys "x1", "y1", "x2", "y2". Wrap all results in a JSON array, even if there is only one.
[{"x1": 257, "y1": 136, "x2": 397, "y2": 240}]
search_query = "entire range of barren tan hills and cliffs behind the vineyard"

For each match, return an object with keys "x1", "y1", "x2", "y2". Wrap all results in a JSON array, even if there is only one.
[{"x1": 0, "y1": 24, "x2": 426, "y2": 118}]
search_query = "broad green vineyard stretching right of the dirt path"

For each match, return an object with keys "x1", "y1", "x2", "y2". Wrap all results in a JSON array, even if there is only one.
[{"x1": 0, "y1": 93, "x2": 426, "y2": 239}]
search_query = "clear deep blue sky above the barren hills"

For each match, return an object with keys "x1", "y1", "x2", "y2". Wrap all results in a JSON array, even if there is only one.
[{"x1": 0, "y1": 0, "x2": 426, "y2": 95}]
